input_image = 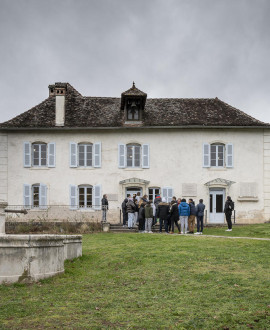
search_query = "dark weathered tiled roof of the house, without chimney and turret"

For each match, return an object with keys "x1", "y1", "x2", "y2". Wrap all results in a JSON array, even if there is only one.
[{"x1": 0, "y1": 84, "x2": 269, "y2": 128}]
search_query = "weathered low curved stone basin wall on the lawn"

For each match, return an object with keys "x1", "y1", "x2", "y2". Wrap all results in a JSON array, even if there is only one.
[{"x1": 0, "y1": 235, "x2": 82, "y2": 284}]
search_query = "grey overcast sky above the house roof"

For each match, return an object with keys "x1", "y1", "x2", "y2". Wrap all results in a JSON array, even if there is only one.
[{"x1": 0, "y1": 0, "x2": 270, "y2": 122}]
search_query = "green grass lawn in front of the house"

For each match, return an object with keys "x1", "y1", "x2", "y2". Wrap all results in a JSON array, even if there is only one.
[{"x1": 0, "y1": 225, "x2": 270, "y2": 329}]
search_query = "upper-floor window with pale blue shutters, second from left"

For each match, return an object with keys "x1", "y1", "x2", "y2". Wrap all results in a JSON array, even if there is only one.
[{"x1": 69, "y1": 142, "x2": 101, "y2": 167}]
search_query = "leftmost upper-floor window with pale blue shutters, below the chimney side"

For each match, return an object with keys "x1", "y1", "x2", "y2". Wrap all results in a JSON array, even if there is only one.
[{"x1": 23, "y1": 142, "x2": 55, "y2": 167}]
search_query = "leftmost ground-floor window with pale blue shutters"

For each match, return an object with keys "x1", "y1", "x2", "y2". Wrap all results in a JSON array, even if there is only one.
[{"x1": 23, "y1": 183, "x2": 47, "y2": 209}]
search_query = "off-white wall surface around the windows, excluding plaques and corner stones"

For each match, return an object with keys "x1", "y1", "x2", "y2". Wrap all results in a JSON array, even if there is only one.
[{"x1": 5, "y1": 129, "x2": 264, "y2": 222}]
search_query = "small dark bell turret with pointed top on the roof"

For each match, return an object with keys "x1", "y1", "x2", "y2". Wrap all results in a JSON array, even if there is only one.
[{"x1": 121, "y1": 81, "x2": 147, "y2": 123}]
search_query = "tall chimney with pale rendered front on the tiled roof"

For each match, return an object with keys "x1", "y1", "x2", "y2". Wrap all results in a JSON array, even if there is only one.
[{"x1": 49, "y1": 82, "x2": 67, "y2": 126}]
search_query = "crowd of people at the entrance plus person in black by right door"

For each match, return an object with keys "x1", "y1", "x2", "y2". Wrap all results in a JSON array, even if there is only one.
[{"x1": 122, "y1": 192, "x2": 234, "y2": 235}]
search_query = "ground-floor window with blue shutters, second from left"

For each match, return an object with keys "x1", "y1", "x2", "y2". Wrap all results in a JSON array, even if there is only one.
[{"x1": 69, "y1": 184, "x2": 102, "y2": 210}]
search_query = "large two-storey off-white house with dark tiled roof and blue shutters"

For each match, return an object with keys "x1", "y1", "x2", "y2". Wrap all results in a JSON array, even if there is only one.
[{"x1": 0, "y1": 83, "x2": 270, "y2": 223}]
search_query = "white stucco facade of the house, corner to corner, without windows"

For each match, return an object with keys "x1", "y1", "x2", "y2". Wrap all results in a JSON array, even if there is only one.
[{"x1": 0, "y1": 128, "x2": 270, "y2": 223}]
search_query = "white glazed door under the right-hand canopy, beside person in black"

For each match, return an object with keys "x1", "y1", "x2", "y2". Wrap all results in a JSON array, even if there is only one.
[{"x1": 209, "y1": 189, "x2": 225, "y2": 223}]
